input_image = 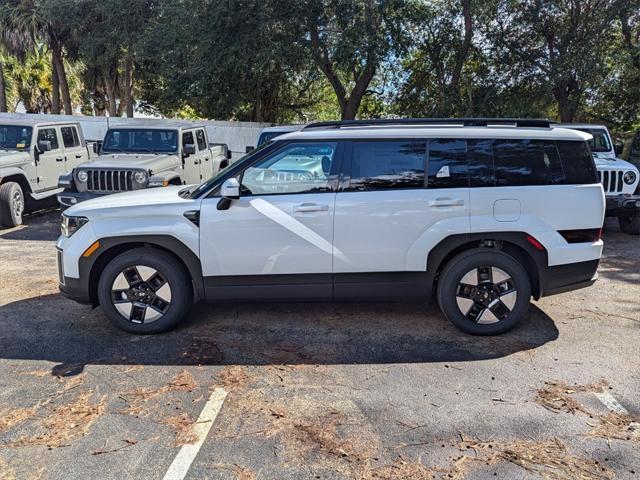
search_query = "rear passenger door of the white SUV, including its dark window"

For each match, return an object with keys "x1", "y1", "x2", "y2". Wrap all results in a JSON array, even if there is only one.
[{"x1": 334, "y1": 139, "x2": 469, "y2": 298}]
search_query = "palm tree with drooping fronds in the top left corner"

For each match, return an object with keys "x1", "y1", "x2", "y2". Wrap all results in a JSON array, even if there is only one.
[{"x1": 0, "y1": 0, "x2": 73, "y2": 115}]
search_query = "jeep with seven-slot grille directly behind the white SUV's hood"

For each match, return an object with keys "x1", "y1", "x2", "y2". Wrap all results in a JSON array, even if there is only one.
[{"x1": 58, "y1": 124, "x2": 231, "y2": 207}]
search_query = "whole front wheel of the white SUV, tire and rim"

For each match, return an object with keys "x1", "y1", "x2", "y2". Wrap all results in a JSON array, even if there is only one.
[{"x1": 98, "y1": 247, "x2": 193, "y2": 334}]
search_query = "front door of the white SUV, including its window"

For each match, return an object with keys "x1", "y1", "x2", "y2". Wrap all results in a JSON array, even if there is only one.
[{"x1": 200, "y1": 142, "x2": 337, "y2": 299}]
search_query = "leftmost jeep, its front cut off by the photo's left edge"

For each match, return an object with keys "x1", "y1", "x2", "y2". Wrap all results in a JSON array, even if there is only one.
[{"x1": 0, "y1": 118, "x2": 89, "y2": 227}]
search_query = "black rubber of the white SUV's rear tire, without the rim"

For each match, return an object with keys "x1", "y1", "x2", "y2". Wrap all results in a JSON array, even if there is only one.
[{"x1": 438, "y1": 249, "x2": 531, "y2": 335}]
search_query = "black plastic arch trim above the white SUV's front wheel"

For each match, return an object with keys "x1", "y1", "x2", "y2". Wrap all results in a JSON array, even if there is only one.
[{"x1": 79, "y1": 235, "x2": 204, "y2": 306}]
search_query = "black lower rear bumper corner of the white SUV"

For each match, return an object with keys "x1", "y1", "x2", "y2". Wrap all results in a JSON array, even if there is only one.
[{"x1": 540, "y1": 260, "x2": 600, "y2": 297}]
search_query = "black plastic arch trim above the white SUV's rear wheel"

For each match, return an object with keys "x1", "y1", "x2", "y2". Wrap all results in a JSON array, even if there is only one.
[{"x1": 427, "y1": 232, "x2": 548, "y2": 300}]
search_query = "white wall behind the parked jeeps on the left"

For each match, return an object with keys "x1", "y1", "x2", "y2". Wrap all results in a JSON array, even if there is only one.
[{"x1": 0, "y1": 113, "x2": 271, "y2": 160}]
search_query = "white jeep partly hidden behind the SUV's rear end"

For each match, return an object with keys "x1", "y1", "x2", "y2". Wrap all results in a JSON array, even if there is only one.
[{"x1": 559, "y1": 124, "x2": 640, "y2": 235}]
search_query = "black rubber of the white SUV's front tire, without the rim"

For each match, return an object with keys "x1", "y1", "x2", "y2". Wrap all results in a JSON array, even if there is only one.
[{"x1": 98, "y1": 248, "x2": 193, "y2": 334}]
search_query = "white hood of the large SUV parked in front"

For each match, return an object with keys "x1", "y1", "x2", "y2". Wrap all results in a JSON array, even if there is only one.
[{"x1": 65, "y1": 185, "x2": 193, "y2": 216}]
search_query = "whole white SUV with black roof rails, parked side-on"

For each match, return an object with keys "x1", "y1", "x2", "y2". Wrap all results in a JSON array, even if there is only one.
[{"x1": 57, "y1": 119, "x2": 605, "y2": 335}]
